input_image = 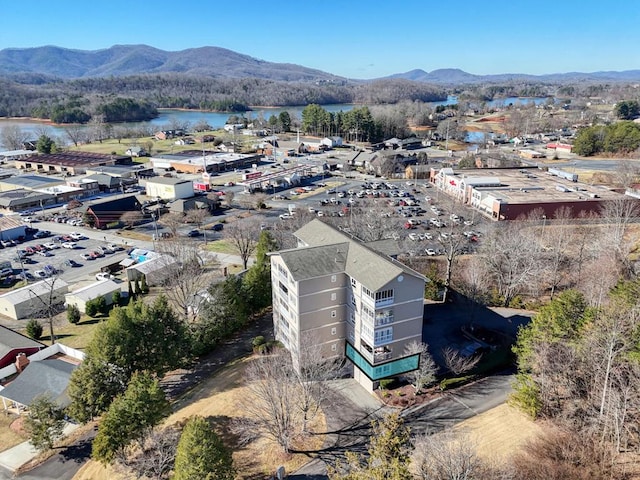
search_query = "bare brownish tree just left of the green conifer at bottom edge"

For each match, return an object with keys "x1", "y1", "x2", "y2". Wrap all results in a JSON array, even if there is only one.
[{"x1": 115, "y1": 426, "x2": 180, "y2": 480}]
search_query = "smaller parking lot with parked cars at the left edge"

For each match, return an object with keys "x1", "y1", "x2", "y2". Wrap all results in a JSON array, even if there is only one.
[{"x1": 0, "y1": 222, "x2": 126, "y2": 286}]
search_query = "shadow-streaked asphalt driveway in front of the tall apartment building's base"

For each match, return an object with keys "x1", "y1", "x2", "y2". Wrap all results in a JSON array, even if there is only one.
[{"x1": 288, "y1": 375, "x2": 513, "y2": 480}]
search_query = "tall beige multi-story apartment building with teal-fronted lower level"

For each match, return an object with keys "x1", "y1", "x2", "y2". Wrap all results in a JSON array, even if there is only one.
[{"x1": 271, "y1": 220, "x2": 425, "y2": 391}]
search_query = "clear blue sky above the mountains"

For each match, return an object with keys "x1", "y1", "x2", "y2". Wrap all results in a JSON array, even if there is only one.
[{"x1": 0, "y1": 0, "x2": 640, "y2": 78}]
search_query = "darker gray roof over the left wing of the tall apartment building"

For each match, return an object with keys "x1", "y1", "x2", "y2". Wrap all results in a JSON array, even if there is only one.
[{"x1": 278, "y1": 242, "x2": 349, "y2": 282}]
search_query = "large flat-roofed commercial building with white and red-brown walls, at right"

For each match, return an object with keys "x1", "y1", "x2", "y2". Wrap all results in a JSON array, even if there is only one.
[{"x1": 429, "y1": 168, "x2": 630, "y2": 220}]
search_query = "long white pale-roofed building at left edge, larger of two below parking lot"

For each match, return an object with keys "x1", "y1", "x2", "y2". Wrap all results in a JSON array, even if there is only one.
[{"x1": 0, "y1": 277, "x2": 69, "y2": 320}]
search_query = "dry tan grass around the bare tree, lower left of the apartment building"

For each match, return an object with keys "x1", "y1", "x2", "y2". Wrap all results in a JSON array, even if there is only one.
[{"x1": 73, "y1": 357, "x2": 326, "y2": 480}]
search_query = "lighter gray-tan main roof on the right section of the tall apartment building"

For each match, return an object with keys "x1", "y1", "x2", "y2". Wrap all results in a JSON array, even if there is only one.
[{"x1": 287, "y1": 219, "x2": 424, "y2": 291}]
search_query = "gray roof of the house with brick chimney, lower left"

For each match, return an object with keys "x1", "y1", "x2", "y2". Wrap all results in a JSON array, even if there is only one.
[{"x1": 0, "y1": 359, "x2": 77, "y2": 407}]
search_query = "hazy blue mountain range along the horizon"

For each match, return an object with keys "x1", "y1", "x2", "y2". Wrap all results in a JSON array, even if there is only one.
[{"x1": 0, "y1": 45, "x2": 640, "y2": 85}]
